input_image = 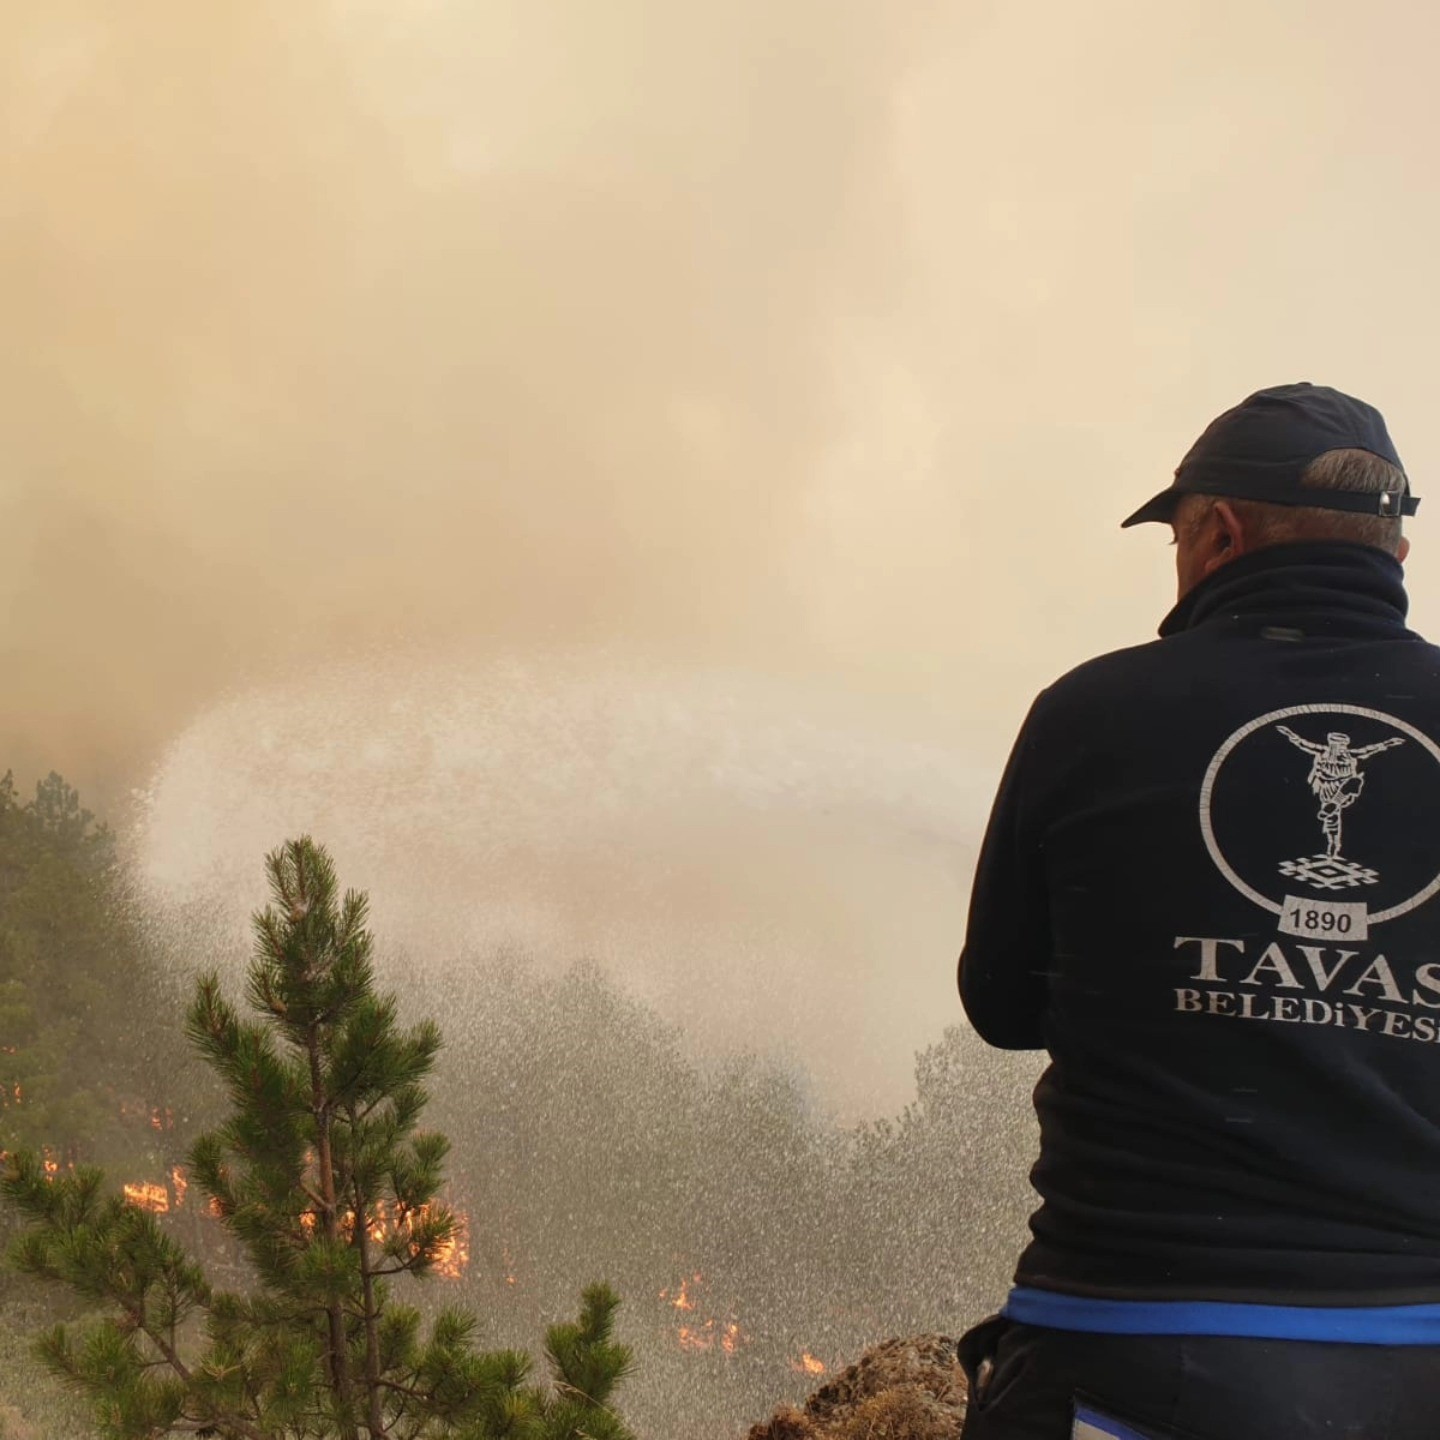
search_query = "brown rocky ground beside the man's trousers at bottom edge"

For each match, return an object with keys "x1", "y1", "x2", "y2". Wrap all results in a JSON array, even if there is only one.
[{"x1": 749, "y1": 1335, "x2": 965, "y2": 1440}]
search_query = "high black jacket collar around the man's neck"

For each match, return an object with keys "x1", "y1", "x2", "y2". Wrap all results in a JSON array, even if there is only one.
[{"x1": 1159, "y1": 540, "x2": 1410, "y2": 636}]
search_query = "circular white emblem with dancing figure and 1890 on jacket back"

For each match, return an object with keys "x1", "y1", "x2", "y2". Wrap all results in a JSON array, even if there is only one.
[{"x1": 1200, "y1": 704, "x2": 1440, "y2": 939}]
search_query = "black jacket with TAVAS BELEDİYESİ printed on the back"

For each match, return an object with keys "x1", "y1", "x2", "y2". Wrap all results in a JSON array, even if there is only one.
[{"x1": 960, "y1": 544, "x2": 1440, "y2": 1305}]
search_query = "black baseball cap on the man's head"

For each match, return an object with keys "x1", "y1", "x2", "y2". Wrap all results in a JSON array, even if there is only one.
[{"x1": 1122, "y1": 384, "x2": 1420, "y2": 528}]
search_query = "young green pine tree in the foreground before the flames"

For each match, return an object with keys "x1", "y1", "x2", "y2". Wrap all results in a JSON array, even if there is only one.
[{"x1": 3, "y1": 838, "x2": 631, "y2": 1440}]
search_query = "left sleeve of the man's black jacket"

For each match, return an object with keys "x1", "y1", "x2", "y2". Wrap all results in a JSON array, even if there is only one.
[{"x1": 959, "y1": 700, "x2": 1051, "y2": 1050}]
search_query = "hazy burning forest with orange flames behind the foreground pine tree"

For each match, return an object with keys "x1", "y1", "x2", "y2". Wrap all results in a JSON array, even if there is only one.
[{"x1": 0, "y1": 796, "x2": 1022, "y2": 1437}]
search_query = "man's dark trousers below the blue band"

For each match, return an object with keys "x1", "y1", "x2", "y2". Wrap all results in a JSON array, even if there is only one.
[{"x1": 960, "y1": 1318, "x2": 1440, "y2": 1440}]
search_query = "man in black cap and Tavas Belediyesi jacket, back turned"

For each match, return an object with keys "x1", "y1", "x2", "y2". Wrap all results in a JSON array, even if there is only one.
[{"x1": 960, "y1": 384, "x2": 1440, "y2": 1440}]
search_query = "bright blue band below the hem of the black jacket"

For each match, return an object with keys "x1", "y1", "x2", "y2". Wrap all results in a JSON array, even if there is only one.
[{"x1": 1001, "y1": 1286, "x2": 1440, "y2": 1345}]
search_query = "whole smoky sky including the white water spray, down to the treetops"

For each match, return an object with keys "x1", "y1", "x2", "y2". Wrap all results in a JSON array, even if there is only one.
[{"x1": 0, "y1": 0, "x2": 1440, "y2": 1113}]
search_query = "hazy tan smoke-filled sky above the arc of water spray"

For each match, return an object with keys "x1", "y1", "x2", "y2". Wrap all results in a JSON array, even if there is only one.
[{"x1": 11, "y1": 0, "x2": 1440, "y2": 792}]
